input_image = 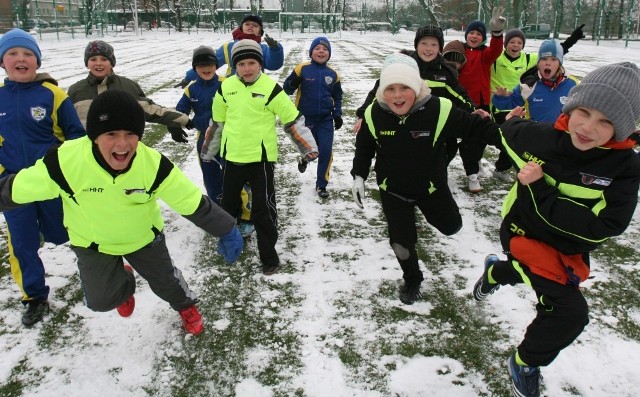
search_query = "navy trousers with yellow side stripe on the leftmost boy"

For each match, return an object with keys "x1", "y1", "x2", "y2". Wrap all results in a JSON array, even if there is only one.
[{"x1": 4, "y1": 198, "x2": 69, "y2": 303}]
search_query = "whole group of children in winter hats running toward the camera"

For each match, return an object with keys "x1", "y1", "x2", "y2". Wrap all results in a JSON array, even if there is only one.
[{"x1": 0, "y1": 13, "x2": 640, "y2": 396}]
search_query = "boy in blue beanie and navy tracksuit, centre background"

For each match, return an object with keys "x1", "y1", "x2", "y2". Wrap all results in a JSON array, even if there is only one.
[{"x1": 283, "y1": 37, "x2": 342, "y2": 198}]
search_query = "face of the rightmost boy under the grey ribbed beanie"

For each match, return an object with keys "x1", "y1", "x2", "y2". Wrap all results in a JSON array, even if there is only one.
[{"x1": 569, "y1": 107, "x2": 615, "y2": 151}]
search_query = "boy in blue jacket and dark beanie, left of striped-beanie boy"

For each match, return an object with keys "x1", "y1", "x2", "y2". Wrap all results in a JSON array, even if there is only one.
[{"x1": 176, "y1": 46, "x2": 224, "y2": 204}]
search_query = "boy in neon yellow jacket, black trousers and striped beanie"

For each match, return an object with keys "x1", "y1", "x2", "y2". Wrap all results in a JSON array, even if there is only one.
[{"x1": 202, "y1": 40, "x2": 318, "y2": 275}]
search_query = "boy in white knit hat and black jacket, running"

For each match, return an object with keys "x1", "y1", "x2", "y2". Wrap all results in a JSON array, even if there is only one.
[{"x1": 351, "y1": 53, "x2": 499, "y2": 305}]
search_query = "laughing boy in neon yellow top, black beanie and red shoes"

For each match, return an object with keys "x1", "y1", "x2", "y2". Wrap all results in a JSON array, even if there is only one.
[{"x1": 0, "y1": 90, "x2": 243, "y2": 335}]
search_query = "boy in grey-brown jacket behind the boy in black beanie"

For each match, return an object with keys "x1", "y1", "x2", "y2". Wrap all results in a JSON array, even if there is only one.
[{"x1": 68, "y1": 40, "x2": 193, "y2": 143}]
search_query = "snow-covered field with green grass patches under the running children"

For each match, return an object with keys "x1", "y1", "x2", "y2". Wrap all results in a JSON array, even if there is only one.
[{"x1": 0, "y1": 31, "x2": 640, "y2": 397}]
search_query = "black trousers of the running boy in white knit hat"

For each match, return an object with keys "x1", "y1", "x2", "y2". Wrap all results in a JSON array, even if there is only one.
[{"x1": 380, "y1": 184, "x2": 462, "y2": 286}]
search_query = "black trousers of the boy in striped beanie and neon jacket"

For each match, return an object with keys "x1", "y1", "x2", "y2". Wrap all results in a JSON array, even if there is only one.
[{"x1": 221, "y1": 161, "x2": 280, "y2": 266}]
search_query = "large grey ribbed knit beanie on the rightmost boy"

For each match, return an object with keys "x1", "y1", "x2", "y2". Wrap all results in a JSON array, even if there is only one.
[{"x1": 562, "y1": 62, "x2": 640, "y2": 142}]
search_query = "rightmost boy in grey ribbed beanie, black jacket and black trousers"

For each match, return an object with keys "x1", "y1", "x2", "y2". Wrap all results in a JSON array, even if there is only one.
[{"x1": 473, "y1": 62, "x2": 640, "y2": 396}]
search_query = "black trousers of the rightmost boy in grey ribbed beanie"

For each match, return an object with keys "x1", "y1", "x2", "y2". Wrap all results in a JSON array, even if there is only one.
[{"x1": 491, "y1": 224, "x2": 589, "y2": 367}]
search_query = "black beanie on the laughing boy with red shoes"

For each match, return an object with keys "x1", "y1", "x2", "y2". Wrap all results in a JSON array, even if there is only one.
[{"x1": 87, "y1": 90, "x2": 144, "y2": 141}]
